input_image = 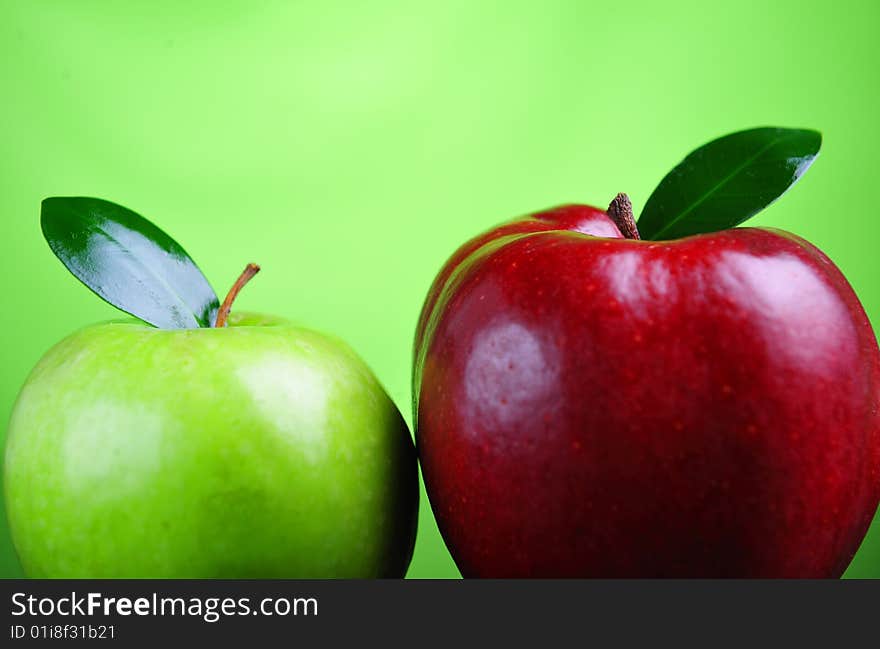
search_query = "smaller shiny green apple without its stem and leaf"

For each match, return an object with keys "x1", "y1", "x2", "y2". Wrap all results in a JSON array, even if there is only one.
[{"x1": 4, "y1": 313, "x2": 418, "y2": 578}]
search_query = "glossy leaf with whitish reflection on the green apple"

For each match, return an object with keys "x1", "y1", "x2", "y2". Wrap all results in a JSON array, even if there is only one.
[{"x1": 40, "y1": 197, "x2": 219, "y2": 329}]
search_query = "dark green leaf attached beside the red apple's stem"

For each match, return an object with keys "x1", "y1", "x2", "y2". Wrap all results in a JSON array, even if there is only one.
[{"x1": 638, "y1": 128, "x2": 822, "y2": 240}]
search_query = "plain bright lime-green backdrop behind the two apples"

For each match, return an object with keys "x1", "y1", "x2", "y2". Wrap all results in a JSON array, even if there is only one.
[{"x1": 0, "y1": 0, "x2": 880, "y2": 577}]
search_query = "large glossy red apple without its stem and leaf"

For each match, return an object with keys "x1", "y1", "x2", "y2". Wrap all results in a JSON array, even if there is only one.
[{"x1": 413, "y1": 205, "x2": 880, "y2": 577}]
